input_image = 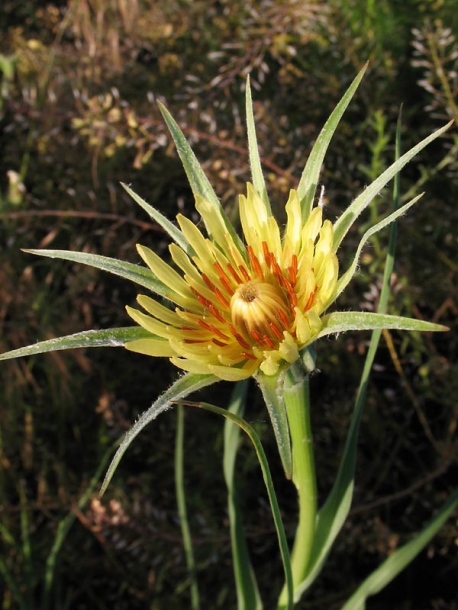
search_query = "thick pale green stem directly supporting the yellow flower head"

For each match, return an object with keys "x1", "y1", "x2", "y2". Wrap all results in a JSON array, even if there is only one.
[{"x1": 278, "y1": 364, "x2": 317, "y2": 609}]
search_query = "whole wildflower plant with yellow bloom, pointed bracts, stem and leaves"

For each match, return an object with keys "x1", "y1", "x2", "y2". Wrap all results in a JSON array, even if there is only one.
[{"x1": 0, "y1": 66, "x2": 458, "y2": 610}]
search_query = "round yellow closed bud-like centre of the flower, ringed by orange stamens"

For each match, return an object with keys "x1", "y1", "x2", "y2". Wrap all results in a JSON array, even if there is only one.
[{"x1": 230, "y1": 280, "x2": 292, "y2": 349}]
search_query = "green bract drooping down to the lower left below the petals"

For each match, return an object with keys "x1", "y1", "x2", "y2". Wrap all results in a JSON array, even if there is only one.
[{"x1": 100, "y1": 373, "x2": 219, "y2": 496}]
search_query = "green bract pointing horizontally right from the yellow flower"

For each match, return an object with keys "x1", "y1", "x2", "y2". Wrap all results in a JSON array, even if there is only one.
[{"x1": 318, "y1": 311, "x2": 448, "y2": 338}]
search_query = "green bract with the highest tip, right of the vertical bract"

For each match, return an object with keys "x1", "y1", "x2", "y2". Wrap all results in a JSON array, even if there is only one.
[{"x1": 297, "y1": 63, "x2": 369, "y2": 222}]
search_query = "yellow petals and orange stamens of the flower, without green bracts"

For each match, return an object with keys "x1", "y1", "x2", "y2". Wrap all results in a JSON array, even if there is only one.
[{"x1": 126, "y1": 184, "x2": 338, "y2": 381}]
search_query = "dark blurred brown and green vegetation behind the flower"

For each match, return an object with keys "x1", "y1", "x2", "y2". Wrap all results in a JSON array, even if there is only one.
[{"x1": 0, "y1": 0, "x2": 458, "y2": 610}]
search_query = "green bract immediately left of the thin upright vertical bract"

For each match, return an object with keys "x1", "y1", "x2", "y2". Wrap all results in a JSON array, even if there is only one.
[{"x1": 158, "y1": 102, "x2": 245, "y2": 252}]
